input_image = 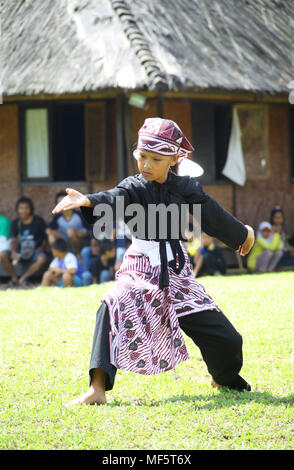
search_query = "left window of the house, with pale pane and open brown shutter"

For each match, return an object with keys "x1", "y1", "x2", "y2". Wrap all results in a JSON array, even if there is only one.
[{"x1": 20, "y1": 102, "x2": 106, "y2": 182}]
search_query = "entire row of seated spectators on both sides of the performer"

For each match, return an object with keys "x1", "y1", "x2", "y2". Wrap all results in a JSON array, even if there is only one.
[{"x1": 0, "y1": 196, "x2": 294, "y2": 287}]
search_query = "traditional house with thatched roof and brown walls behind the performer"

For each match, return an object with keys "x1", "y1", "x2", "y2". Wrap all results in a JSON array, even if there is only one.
[{"x1": 0, "y1": 0, "x2": 294, "y2": 235}]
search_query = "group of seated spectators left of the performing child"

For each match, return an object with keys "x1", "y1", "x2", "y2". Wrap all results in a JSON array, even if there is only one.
[{"x1": 0, "y1": 192, "x2": 130, "y2": 287}]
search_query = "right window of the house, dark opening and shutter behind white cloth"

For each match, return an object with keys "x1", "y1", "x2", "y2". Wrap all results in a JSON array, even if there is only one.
[{"x1": 192, "y1": 101, "x2": 270, "y2": 184}]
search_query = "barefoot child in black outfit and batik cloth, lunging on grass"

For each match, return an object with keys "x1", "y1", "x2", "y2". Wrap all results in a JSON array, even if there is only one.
[{"x1": 53, "y1": 118, "x2": 254, "y2": 406}]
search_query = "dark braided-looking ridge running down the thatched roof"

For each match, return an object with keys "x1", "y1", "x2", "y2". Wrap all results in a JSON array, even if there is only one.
[{"x1": 111, "y1": 0, "x2": 168, "y2": 91}]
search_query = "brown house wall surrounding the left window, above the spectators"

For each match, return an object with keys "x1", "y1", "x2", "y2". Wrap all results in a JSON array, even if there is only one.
[{"x1": 0, "y1": 100, "x2": 117, "y2": 221}]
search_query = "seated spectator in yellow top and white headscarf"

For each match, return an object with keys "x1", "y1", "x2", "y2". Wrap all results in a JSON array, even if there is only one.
[{"x1": 247, "y1": 222, "x2": 283, "y2": 273}]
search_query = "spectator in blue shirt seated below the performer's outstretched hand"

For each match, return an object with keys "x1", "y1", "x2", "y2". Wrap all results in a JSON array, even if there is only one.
[{"x1": 46, "y1": 191, "x2": 89, "y2": 255}]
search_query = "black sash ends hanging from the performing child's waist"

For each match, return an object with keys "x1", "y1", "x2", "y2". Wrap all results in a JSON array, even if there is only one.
[{"x1": 159, "y1": 239, "x2": 185, "y2": 290}]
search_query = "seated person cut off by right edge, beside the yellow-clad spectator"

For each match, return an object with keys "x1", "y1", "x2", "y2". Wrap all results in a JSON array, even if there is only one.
[{"x1": 270, "y1": 206, "x2": 294, "y2": 268}]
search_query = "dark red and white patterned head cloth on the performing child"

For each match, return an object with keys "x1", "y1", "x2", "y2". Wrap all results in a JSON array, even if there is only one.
[{"x1": 137, "y1": 118, "x2": 194, "y2": 158}]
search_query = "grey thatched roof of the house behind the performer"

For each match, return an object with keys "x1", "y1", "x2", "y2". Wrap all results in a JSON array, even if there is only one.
[{"x1": 0, "y1": 0, "x2": 294, "y2": 96}]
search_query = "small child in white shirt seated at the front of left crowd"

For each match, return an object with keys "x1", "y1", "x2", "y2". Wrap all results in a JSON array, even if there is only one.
[{"x1": 42, "y1": 238, "x2": 83, "y2": 287}]
